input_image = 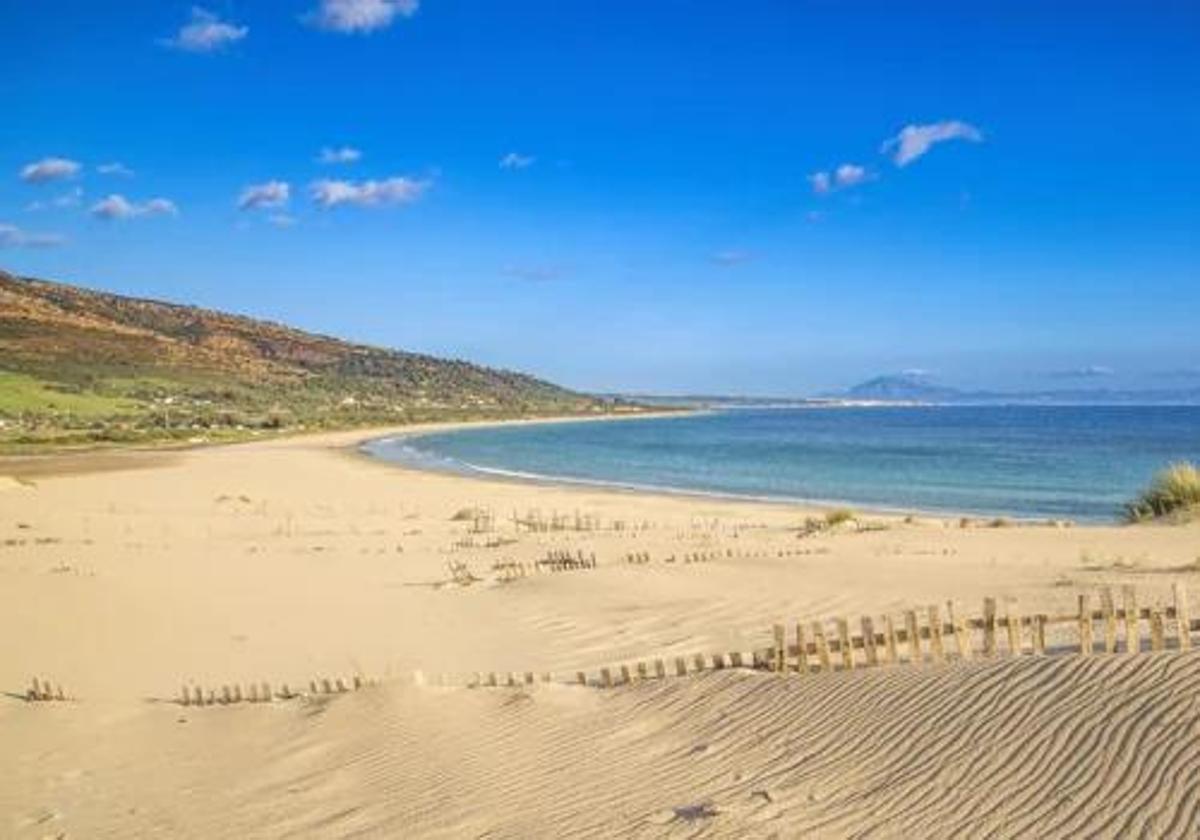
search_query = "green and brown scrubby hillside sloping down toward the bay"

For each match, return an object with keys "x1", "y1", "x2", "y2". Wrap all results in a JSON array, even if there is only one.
[{"x1": 0, "y1": 271, "x2": 612, "y2": 442}]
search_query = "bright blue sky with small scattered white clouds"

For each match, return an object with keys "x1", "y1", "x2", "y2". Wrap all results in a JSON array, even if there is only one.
[{"x1": 0, "y1": 0, "x2": 1200, "y2": 396}]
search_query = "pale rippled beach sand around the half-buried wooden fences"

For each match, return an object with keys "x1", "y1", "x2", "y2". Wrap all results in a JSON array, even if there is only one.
[{"x1": 0, "y1": 422, "x2": 1200, "y2": 838}]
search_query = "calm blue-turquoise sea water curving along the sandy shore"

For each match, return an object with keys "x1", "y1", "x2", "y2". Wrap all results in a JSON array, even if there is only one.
[{"x1": 367, "y1": 406, "x2": 1200, "y2": 520}]
